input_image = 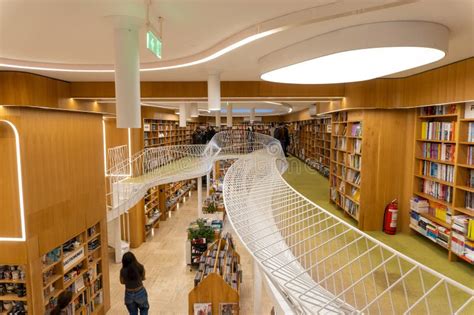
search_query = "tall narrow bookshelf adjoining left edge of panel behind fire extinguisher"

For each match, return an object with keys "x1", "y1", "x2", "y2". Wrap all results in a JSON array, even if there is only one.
[{"x1": 329, "y1": 112, "x2": 363, "y2": 222}]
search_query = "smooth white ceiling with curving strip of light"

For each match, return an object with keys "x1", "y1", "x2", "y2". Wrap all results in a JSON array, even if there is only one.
[{"x1": 0, "y1": 0, "x2": 474, "y2": 81}]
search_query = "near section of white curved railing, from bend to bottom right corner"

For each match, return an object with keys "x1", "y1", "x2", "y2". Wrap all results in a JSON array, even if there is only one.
[{"x1": 224, "y1": 151, "x2": 474, "y2": 314}]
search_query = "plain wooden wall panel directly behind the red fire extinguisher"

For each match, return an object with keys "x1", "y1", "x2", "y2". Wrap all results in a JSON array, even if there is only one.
[{"x1": 358, "y1": 110, "x2": 414, "y2": 230}]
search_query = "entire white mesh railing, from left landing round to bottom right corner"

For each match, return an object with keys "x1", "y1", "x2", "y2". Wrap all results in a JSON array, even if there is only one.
[{"x1": 108, "y1": 131, "x2": 474, "y2": 314}]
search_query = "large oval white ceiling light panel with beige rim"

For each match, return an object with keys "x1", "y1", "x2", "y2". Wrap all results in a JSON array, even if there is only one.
[{"x1": 259, "y1": 22, "x2": 449, "y2": 84}]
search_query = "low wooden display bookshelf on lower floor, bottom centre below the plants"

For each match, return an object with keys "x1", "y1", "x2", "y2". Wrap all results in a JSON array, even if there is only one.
[{"x1": 188, "y1": 233, "x2": 242, "y2": 315}]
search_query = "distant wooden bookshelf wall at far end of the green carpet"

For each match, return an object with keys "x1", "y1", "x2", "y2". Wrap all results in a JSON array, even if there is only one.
[{"x1": 288, "y1": 117, "x2": 332, "y2": 177}]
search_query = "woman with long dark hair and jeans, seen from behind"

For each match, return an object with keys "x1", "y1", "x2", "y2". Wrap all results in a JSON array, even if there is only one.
[{"x1": 120, "y1": 252, "x2": 150, "y2": 315}]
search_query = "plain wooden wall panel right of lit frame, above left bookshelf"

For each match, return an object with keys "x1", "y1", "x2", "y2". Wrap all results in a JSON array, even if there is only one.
[{"x1": 3, "y1": 108, "x2": 105, "y2": 254}]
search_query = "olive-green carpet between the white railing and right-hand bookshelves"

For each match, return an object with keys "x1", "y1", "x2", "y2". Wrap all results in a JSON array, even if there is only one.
[{"x1": 283, "y1": 157, "x2": 474, "y2": 289}]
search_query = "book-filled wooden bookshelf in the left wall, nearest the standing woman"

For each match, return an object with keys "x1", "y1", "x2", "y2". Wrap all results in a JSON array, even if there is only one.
[{"x1": 41, "y1": 223, "x2": 105, "y2": 315}]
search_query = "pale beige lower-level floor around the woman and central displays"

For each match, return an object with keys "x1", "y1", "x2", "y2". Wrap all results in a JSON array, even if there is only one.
[{"x1": 107, "y1": 191, "x2": 271, "y2": 315}]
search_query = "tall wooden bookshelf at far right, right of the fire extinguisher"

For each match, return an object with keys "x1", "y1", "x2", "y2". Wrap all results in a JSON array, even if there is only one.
[{"x1": 410, "y1": 104, "x2": 474, "y2": 264}]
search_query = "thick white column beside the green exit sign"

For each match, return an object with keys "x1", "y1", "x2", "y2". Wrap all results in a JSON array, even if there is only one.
[{"x1": 114, "y1": 16, "x2": 141, "y2": 128}]
